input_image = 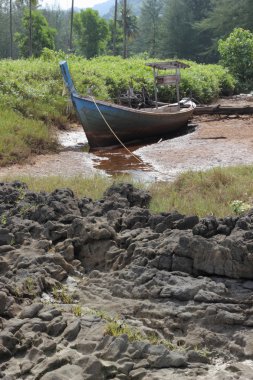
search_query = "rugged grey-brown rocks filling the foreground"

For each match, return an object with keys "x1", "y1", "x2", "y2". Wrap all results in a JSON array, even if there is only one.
[{"x1": 0, "y1": 182, "x2": 253, "y2": 380}]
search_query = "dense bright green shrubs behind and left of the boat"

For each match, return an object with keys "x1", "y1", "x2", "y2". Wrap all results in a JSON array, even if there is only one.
[{"x1": 0, "y1": 49, "x2": 234, "y2": 116}]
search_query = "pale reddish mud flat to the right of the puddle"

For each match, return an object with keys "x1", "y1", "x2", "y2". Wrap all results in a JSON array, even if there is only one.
[{"x1": 135, "y1": 116, "x2": 253, "y2": 180}]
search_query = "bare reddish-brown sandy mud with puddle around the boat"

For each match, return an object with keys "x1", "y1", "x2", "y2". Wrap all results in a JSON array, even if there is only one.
[{"x1": 0, "y1": 99, "x2": 253, "y2": 181}]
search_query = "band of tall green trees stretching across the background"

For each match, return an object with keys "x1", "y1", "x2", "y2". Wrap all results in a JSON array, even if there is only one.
[{"x1": 0, "y1": 0, "x2": 253, "y2": 63}]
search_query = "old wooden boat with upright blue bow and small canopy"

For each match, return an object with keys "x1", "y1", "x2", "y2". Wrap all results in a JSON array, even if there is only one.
[{"x1": 60, "y1": 61, "x2": 195, "y2": 149}]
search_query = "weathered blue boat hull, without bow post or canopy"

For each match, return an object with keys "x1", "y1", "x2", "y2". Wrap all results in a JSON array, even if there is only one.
[{"x1": 72, "y1": 95, "x2": 193, "y2": 148}]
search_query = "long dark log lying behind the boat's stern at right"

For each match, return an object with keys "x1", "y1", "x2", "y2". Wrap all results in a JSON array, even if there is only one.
[{"x1": 194, "y1": 104, "x2": 253, "y2": 115}]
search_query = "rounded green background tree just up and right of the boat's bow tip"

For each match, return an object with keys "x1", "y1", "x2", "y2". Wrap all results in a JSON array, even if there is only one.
[{"x1": 74, "y1": 8, "x2": 109, "y2": 58}]
